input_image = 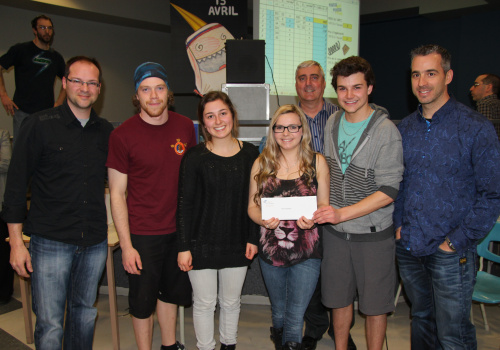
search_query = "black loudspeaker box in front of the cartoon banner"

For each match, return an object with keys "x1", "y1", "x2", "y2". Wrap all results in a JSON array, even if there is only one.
[{"x1": 226, "y1": 40, "x2": 266, "y2": 84}]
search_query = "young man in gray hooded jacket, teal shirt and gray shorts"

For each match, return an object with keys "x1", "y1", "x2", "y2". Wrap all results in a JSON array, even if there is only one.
[{"x1": 313, "y1": 57, "x2": 403, "y2": 350}]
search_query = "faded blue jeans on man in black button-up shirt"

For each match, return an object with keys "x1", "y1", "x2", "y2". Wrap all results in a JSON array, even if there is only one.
[{"x1": 30, "y1": 235, "x2": 107, "y2": 350}]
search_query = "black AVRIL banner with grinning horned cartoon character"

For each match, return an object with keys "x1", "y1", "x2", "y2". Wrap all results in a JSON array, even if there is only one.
[{"x1": 170, "y1": 0, "x2": 248, "y2": 95}]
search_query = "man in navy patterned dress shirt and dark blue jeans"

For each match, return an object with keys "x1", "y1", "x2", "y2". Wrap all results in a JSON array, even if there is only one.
[{"x1": 394, "y1": 45, "x2": 500, "y2": 350}]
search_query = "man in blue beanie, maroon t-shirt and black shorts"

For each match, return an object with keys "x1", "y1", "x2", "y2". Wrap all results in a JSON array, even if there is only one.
[{"x1": 106, "y1": 62, "x2": 196, "y2": 350}]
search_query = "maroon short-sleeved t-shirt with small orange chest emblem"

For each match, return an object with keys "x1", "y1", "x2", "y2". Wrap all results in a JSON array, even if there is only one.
[{"x1": 106, "y1": 111, "x2": 196, "y2": 235}]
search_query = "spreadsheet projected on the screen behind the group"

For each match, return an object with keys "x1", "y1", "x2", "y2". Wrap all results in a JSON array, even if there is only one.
[{"x1": 254, "y1": 0, "x2": 359, "y2": 97}]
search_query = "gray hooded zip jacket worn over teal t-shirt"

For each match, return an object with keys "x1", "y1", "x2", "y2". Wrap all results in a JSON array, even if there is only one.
[{"x1": 325, "y1": 104, "x2": 404, "y2": 241}]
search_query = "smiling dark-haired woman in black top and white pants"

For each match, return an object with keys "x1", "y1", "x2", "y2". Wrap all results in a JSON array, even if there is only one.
[{"x1": 177, "y1": 91, "x2": 259, "y2": 350}]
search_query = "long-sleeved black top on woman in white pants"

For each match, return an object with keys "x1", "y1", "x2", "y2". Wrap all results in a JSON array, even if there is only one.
[{"x1": 177, "y1": 142, "x2": 259, "y2": 270}]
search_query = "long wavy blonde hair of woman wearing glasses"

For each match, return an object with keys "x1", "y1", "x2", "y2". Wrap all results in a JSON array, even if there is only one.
[{"x1": 253, "y1": 105, "x2": 316, "y2": 204}]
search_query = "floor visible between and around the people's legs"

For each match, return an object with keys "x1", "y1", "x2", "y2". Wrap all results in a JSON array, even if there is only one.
[{"x1": 0, "y1": 290, "x2": 500, "y2": 350}]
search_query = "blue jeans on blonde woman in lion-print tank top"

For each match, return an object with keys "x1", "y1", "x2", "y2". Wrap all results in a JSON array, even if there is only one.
[{"x1": 259, "y1": 258, "x2": 321, "y2": 344}]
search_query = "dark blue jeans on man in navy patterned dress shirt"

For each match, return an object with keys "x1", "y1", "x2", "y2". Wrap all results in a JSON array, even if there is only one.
[{"x1": 396, "y1": 242, "x2": 477, "y2": 350}]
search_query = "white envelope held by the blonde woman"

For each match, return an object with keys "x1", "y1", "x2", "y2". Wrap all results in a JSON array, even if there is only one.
[{"x1": 260, "y1": 196, "x2": 318, "y2": 220}]
